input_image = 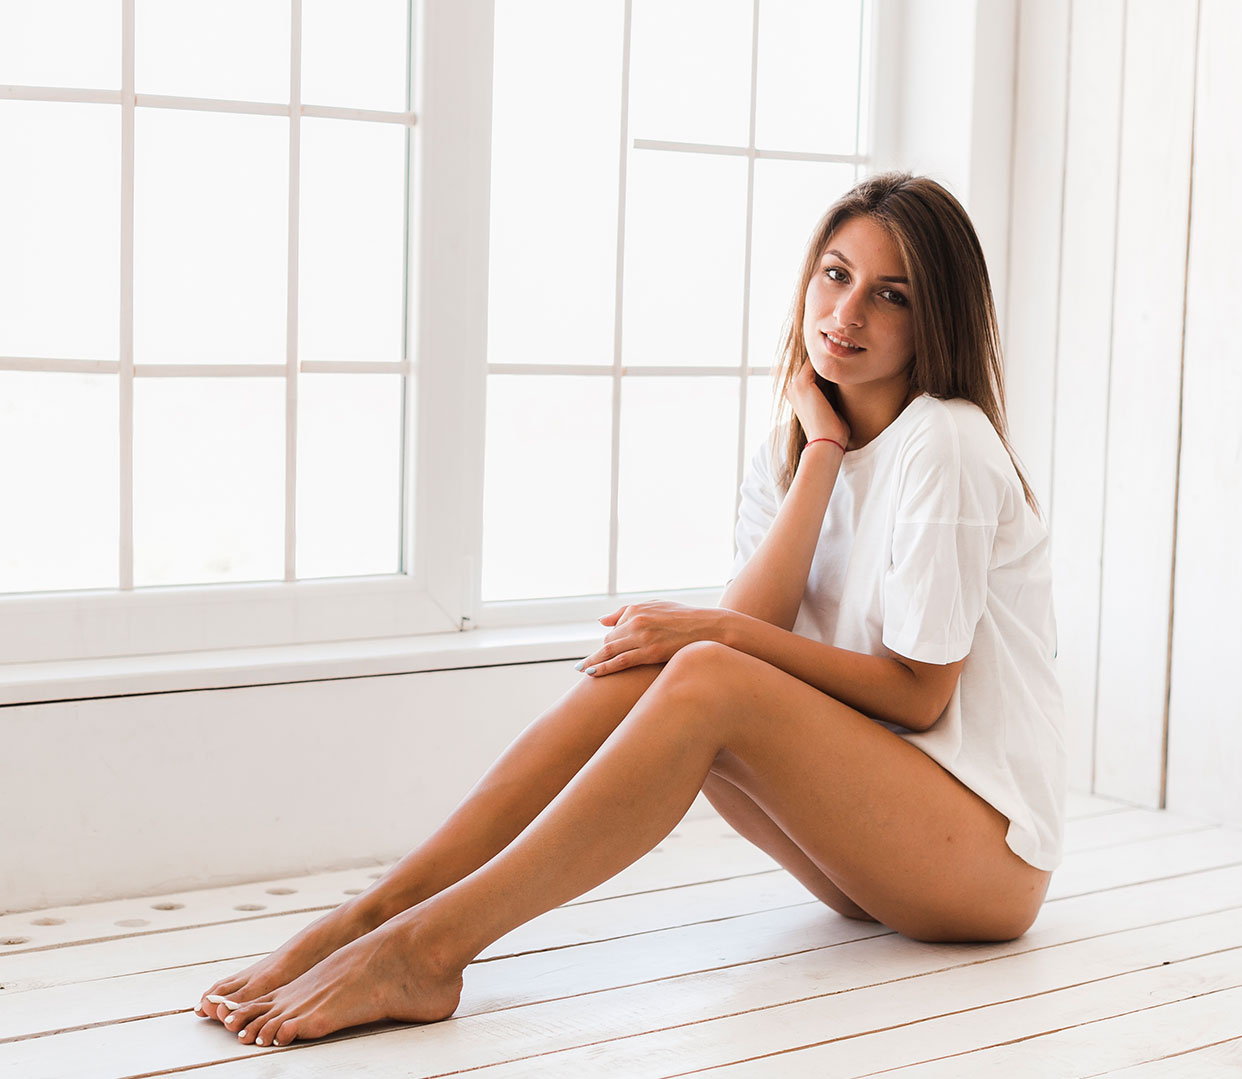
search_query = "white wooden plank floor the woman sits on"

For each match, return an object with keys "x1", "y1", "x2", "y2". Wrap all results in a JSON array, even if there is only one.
[{"x1": 0, "y1": 796, "x2": 1242, "y2": 1079}]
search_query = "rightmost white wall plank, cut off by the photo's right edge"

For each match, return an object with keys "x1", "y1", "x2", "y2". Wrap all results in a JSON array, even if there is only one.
[{"x1": 1169, "y1": 0, "x2": 1242, "y2": 826}]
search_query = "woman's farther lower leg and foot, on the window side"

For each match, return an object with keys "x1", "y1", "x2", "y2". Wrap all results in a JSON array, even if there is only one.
[{"x1": 196, "y1": 667, "x2": 661, "y2": 1022}]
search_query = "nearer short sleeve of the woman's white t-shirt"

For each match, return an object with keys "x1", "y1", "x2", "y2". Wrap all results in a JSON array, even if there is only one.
[{"x1": 883, "y1": 416, "x2": 997, "y2": 663}]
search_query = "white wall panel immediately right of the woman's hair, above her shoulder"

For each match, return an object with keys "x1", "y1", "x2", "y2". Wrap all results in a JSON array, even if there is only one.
[{"x1": 1005, "y1": 0, "x2": 1069, "y2": 503}]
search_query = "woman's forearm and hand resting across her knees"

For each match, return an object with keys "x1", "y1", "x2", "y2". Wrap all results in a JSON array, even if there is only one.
[{"x1": 573, "y1": 602, "x2": 965, "y2": 730}]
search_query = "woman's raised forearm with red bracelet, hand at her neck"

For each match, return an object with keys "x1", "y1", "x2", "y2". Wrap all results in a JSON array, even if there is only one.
[{"x1": 719, "y1": 363, "x2": 850, "y2": 630}]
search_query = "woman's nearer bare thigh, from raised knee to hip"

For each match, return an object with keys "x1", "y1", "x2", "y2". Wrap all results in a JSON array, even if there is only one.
[{"x1": 656, "y1": 643, "x2": 1049, "y2": 940}]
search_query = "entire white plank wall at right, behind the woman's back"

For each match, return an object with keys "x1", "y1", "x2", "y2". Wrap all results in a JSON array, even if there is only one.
[{"x1": 1006, "y1": 0, "x2": 1242, "y2": 823}]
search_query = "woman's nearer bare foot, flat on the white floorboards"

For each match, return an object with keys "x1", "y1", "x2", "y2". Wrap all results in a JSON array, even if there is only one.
[{"x1": 218, "y1": 911, "x2": 462, "y2": 1045}]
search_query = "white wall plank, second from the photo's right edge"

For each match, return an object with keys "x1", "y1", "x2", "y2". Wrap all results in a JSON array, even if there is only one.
[{"x1": 1092, "y1": 0, "x2": 1197, "y2": 806}]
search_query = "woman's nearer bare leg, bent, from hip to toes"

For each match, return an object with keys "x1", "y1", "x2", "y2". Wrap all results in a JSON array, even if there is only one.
[{"x1": 230, "y1": 642, "x2": 1049, "y2": 1044}]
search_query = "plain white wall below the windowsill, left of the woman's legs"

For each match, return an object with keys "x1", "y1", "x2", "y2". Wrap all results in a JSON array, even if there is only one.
[{"x1": 0, "y1": 662, "x2": 582, "y2": 911}]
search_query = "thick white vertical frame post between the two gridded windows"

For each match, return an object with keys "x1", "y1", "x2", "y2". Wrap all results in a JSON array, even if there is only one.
[{"x1": 415, "y1": 0, "x2": 494, "y2": 628}]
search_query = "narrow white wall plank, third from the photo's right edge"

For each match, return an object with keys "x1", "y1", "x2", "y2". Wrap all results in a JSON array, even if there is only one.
[{"x1": 1046, "y1": 0, "x2": 1125, "y2": 790}]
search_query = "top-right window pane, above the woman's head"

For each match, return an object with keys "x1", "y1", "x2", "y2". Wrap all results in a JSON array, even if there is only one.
[{"x1": 755, "y1": 0, "x2": 862, "y2": 154}]
